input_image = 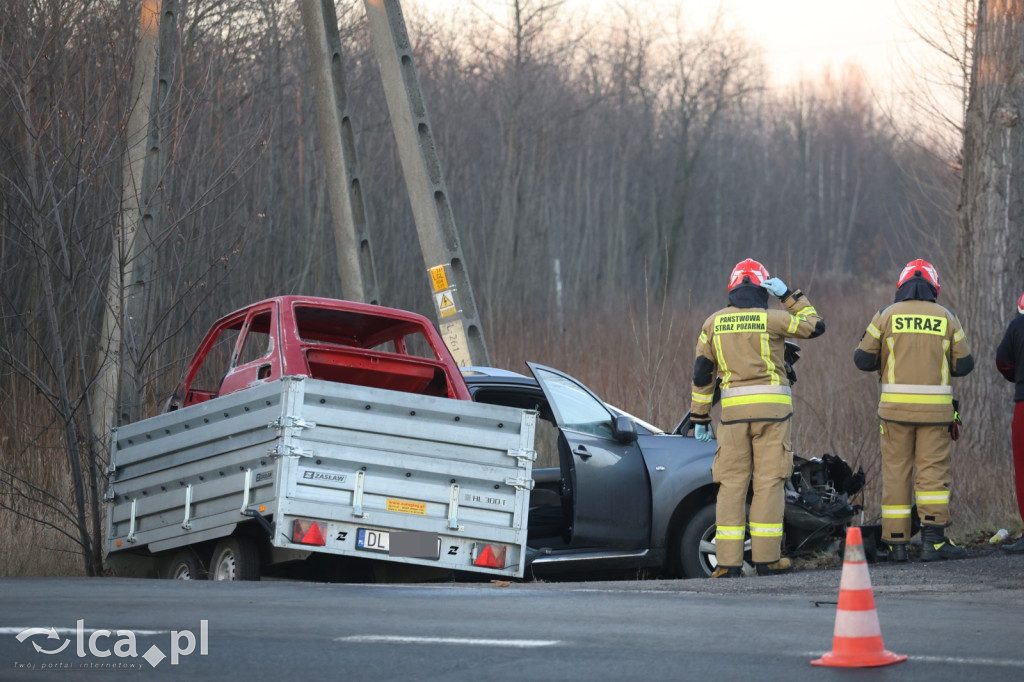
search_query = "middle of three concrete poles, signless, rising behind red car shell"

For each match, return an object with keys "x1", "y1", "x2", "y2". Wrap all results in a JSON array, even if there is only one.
[{"x1": 299, "y1": 0, "x2": 381, "y2": 304}]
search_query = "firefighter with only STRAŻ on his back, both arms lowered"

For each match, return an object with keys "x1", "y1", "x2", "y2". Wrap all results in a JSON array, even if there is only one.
[{"x1": 854, "y1": 259, "x2": 974, "y2": 561}]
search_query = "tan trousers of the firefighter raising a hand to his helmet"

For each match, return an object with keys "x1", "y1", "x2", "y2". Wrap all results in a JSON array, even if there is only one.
[{"x1": 712, "y1": 419, "x2": 793, "y2": 566}]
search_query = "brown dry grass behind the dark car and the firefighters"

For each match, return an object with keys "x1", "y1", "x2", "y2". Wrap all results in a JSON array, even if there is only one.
[{"x1": 490, "y1": 280, "x2": 1022, "y2": 538}]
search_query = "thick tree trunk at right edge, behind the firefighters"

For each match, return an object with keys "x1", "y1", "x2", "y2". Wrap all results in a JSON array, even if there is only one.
[{"x1": 956, "y1": 0, "x2": 1024, "y2": 512}]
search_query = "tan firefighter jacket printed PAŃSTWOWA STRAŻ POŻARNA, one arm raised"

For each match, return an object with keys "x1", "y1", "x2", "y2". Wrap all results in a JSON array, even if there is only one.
[{"x1": 690, "y1": 290, "x2": 824, "y2": 424}]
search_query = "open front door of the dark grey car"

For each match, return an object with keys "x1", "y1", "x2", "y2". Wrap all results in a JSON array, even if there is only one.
[{"x1": 526, "y1": 363, "x2": 650, "y2": 549}]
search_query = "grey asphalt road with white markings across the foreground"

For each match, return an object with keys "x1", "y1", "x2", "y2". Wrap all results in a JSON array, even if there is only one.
[{"x1": 0, "y1": 552, "x2": 1024, "y2": 682}]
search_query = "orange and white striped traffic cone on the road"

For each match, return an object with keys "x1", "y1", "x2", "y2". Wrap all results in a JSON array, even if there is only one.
[{"x1": 811, "y1": 526, "x2": 906, "y2": 668}]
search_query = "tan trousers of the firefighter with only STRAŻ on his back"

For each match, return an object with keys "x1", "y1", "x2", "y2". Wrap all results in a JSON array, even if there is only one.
[{"x1": 879, "y1": 420, "x2": 952, "y2": 543}]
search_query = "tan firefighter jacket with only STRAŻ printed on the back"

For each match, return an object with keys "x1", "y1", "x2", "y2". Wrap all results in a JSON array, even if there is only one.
[{"x1": 854, "y1": 300, "x2": 974, "y2": 424}]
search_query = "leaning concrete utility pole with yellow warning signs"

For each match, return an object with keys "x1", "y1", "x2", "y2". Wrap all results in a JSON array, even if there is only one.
[{"x1": 364, "y1": 0, "x2": 490, "y2": 367}]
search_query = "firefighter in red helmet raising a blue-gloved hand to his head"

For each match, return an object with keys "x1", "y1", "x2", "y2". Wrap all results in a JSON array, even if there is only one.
[{"x1": 690, "y1": 258, "x2": 825, "y2": 578}]
